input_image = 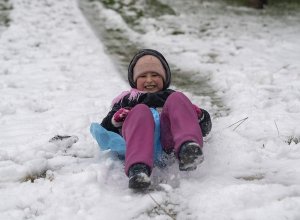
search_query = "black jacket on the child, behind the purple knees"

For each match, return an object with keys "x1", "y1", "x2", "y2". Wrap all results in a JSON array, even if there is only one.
[{"x1": 101, "y1": 89, "x2": 212, "y2": 136}]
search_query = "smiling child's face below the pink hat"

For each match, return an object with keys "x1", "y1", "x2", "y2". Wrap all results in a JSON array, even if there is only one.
[{"x1": 136, "y1": 72, "x2": 164, "y2": 93}]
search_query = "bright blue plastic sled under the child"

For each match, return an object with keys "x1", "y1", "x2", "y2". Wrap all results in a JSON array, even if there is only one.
[{"x1": 90, "y1": 108, "x2": 163, "y2": 166}]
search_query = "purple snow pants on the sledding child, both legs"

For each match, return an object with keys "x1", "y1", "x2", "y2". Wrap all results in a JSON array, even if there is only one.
[{"x1": 122, "y1": 92, "x2": 203, "y2": 174}]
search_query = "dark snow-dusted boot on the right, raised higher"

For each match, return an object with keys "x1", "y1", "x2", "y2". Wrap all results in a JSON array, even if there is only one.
[{"x1": 178, "y1": 141, "x2": 204, "y2": 171}]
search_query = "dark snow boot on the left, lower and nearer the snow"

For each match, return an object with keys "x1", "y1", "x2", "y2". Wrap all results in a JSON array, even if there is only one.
[{"x1": 128, "y1": 163, "x2": 151, "y2": 189}]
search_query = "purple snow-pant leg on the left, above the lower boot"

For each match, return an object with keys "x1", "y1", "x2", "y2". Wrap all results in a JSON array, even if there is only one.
[{"x1": 122, "y1": 104, "x2": 154, "y2": 175}]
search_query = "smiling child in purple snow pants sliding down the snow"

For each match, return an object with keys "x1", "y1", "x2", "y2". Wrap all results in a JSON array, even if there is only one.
[{"x1": 101, "y1": 49, "x2": 211, "y2": 189}]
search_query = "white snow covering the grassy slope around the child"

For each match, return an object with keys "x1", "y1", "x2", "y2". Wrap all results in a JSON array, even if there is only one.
[{"x1": 0, "y1": 0, "x2": 300, "y2": 220}]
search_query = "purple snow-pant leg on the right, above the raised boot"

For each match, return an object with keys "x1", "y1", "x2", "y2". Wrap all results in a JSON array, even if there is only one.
[{"x1": 160, "y1": 92, "x2": 203, "y2": 155}]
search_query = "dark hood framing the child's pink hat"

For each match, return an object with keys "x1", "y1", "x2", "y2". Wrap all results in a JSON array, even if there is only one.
[{"x1": 128, "y1": 49, "x2": 171, "y2": 89}]
